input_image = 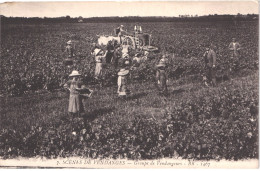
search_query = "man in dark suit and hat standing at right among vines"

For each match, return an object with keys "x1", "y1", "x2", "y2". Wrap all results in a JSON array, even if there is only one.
[{"x1": 206, "y1": 44, "x2": 217, "y2": 87}]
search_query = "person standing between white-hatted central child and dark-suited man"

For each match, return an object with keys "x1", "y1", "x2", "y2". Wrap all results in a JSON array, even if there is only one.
[{"x1": 156, "y1": 55, "x2": 168, "y2": 95}]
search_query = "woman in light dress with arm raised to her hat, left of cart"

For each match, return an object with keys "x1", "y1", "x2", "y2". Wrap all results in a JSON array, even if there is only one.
[{"x1": 94, "y1": 49, "x2": 107, "y2": 80}]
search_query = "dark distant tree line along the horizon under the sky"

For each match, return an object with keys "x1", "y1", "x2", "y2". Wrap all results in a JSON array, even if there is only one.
[{"x1": 0, "y1": 14, "x2": 259, "y2": 24}]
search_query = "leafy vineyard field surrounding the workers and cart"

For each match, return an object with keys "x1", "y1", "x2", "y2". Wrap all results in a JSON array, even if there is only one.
[{"x1": 0, "y1": 21, "x2": 259, "y2": 160}]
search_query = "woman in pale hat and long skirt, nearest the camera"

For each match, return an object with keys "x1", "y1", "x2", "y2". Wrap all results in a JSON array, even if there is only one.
[{"x1": 64, "y1": 70, "x2": 86, "y2": 115}]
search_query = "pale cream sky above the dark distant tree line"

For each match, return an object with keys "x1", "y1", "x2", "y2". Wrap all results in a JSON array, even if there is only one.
[{"x1": 0, "y1": 0, "x2": 259, "y2": 17}]
